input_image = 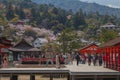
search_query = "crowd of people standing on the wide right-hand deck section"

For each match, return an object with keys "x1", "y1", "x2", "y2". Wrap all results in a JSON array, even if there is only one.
[{"x1": 52, "y1": 53, "x2": 104, "y2": 66}]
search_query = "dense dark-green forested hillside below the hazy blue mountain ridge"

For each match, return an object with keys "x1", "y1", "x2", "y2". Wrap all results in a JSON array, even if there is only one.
[{"x1": 0, "y1": 0, "x2": 120, "y2": 43}]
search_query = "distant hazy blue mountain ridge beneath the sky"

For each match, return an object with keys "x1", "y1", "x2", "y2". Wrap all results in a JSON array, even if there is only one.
[{"x1": 32, "y1": 0, "x2": 120, "y2": 18}]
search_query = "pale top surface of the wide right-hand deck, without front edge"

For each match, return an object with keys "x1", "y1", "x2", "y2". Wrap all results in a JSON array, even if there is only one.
[{"x1": 66, "y1": 61, "x2": 118, "y2": 72}]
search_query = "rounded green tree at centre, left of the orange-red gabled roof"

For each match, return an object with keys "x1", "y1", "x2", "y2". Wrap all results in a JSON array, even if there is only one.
[{"x1": 58, "y1": 29, "x2": 80, "y2": 53}]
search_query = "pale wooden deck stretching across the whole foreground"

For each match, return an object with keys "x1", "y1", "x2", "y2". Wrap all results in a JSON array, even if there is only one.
[{"x1": 0, "y1": 63, "x2": 120, "y2": 75}]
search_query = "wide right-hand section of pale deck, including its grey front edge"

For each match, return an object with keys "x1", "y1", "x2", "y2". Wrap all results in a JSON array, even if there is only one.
[{"x1": 66, "y1": 63, "x2": 120, "y2": 75}]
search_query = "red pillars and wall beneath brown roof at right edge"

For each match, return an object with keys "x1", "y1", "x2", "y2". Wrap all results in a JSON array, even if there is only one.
[{"x1": 103, "y1": 47, "x2": 120, "y2": 71}]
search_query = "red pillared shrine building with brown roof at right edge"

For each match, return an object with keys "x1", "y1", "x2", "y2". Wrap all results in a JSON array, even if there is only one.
[{"x1": 101, "y1": 37, "x2": 120, "y2": 71}]
